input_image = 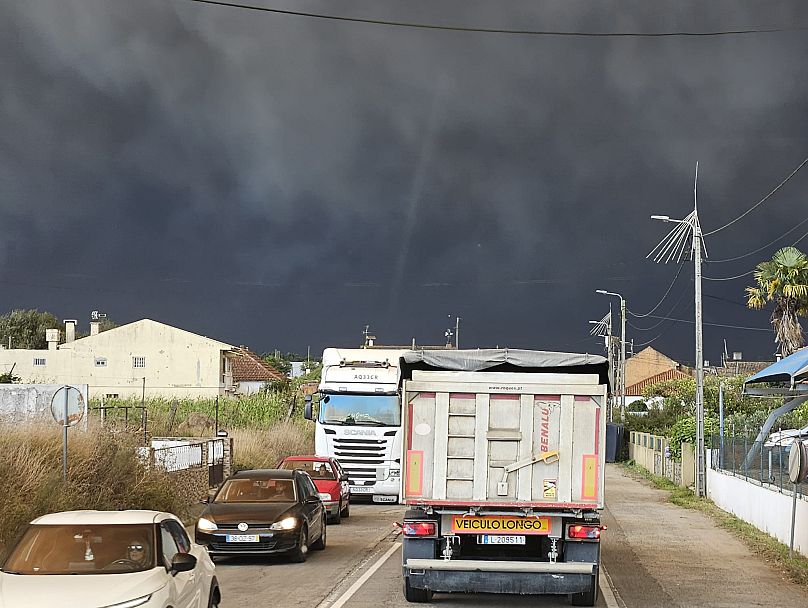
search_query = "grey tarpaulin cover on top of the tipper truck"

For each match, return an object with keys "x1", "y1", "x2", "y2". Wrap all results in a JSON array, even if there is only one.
[{"x1": 402, "y1": 348, "x2": 609, "y2": 384}]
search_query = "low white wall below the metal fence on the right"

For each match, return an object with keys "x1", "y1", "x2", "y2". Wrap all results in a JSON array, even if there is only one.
[{"x1": 707, "y1": 468, "x2": 808, "y2": 556}]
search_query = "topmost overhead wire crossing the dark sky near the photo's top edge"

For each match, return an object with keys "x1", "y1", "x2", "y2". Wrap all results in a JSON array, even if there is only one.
[{"x1": 177, "y1": 0, "x2": 808, "y2": 38}]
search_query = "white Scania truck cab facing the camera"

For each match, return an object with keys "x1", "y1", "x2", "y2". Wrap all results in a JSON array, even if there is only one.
[{"x1": 306, "y1": 348, "x2": 414, "y2": 502}]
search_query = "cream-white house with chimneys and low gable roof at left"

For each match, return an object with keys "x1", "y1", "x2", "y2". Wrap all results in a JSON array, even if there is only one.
[{"x1": 0, "y1": 319, "x2": 240, "y2": 398}]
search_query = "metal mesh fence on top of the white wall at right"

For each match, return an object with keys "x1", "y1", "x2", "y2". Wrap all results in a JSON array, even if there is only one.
[{"x1": 710, "y1": 435, "x2": 808, "y2": 500}]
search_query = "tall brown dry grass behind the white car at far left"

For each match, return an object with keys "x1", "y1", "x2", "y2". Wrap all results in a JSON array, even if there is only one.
[{"x1": 0, "y1": 423, "x2": 186, "y2": 559}]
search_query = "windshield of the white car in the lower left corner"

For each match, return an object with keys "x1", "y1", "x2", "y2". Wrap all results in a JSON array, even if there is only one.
[{"x1": 3, "y1": 524, "x2": 156, "y2": 574}]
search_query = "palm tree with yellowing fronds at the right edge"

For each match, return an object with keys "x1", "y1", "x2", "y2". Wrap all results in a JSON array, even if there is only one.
[{"x1": 746, "y1": 247, "x2": 808, "y2": 357}]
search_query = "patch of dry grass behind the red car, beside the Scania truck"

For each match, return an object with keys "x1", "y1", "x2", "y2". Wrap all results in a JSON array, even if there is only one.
[{"x1": 230, "y1": 420, "x2": 314, "y2": 470}]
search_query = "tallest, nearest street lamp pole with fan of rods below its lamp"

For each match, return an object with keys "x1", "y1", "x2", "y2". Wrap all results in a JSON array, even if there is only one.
[{"x1": 647, "y1": 163, "x2": 706, "y2": 496}]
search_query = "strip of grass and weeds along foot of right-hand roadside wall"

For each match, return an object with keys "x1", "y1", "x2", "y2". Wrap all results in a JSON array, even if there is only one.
[{"x1": 622, "y1": 461, "x2": 808, "y2": 587}]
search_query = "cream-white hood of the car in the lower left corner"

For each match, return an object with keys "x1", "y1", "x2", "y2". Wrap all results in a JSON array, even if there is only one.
[{"x1": 0, "y1": 566, "x2": 167, "y2": 608}]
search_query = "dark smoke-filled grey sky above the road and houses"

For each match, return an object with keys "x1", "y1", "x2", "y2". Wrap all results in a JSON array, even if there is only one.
[{"x1": 0, "y1": 0, "x2": 808, "y2": 362}]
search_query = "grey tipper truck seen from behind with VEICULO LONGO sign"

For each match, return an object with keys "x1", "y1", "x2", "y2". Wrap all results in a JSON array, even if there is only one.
[{"x1": 402, "y1": 350, "x2": 608, "y2": 605}]
